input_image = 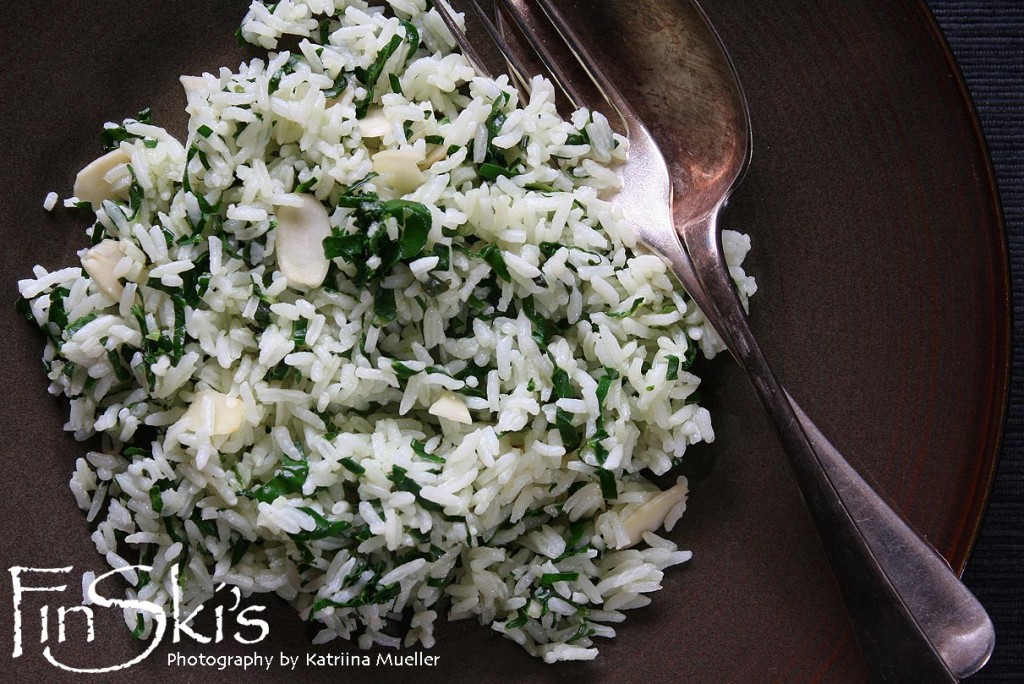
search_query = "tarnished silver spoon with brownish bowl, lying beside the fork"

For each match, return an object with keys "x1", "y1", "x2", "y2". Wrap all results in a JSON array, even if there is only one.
[{"x1": 634, "y1": 1, "x2": 995, "y2": 682}]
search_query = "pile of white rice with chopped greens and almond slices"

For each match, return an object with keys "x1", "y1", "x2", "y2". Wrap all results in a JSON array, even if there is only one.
[{"x1": 19, "y1": 0, "x2": 754, "y2": 661}]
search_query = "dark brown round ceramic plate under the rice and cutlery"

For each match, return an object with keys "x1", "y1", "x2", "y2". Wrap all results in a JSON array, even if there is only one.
[{"x1": 0, "y1": 0, "x2": 1009, "y2": 683}]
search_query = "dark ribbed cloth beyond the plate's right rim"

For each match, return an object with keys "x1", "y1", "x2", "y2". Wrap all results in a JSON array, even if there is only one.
[{"x1": 928, "y1": 0, "x2": 1024, "y2": 682}]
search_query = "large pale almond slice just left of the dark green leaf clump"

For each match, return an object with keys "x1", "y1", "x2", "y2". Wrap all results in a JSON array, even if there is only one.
[{"x1": 275, "y1": 195, "x2": 331, "y2": 288}]
